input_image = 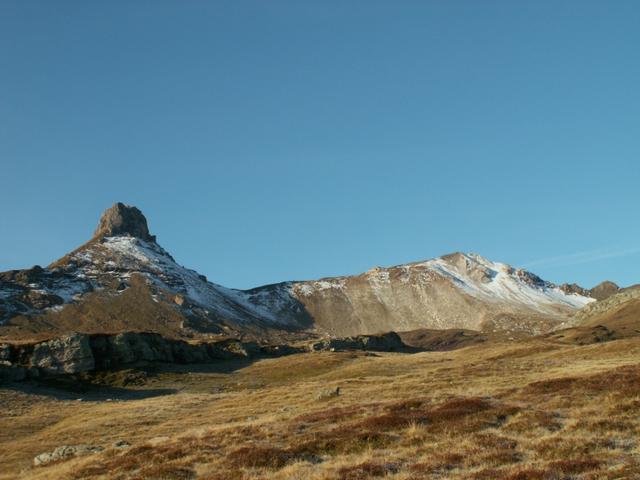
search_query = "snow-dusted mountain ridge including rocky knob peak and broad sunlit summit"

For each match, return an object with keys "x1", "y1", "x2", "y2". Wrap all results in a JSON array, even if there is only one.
[{"x1": 0, "y1": 203, "x2": 593, "y2": 337}]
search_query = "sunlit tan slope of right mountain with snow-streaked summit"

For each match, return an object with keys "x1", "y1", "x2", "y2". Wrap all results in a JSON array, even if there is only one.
[{"x1": 262, "y1": 253, "x2": 592, "y2": 336}]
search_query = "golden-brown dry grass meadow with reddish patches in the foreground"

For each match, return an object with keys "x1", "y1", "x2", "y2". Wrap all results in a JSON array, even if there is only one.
[{"x1": 0, "y1": 337, "x2": 640, "y2": 480}]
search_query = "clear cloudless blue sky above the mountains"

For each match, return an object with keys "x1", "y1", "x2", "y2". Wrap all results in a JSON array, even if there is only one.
[{"x1": 0, "y1": 0, "x2": 640, "y2": 288}]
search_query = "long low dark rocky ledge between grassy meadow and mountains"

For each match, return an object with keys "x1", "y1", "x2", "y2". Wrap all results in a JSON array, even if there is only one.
[{"x1": 0, "y1": 332, "x2": 408, "y2": 381}]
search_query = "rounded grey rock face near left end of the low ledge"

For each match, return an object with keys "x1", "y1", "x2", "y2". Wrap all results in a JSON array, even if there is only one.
[{"x1": 31, "y1": 334, "x2": 95, "y2": 375}]
